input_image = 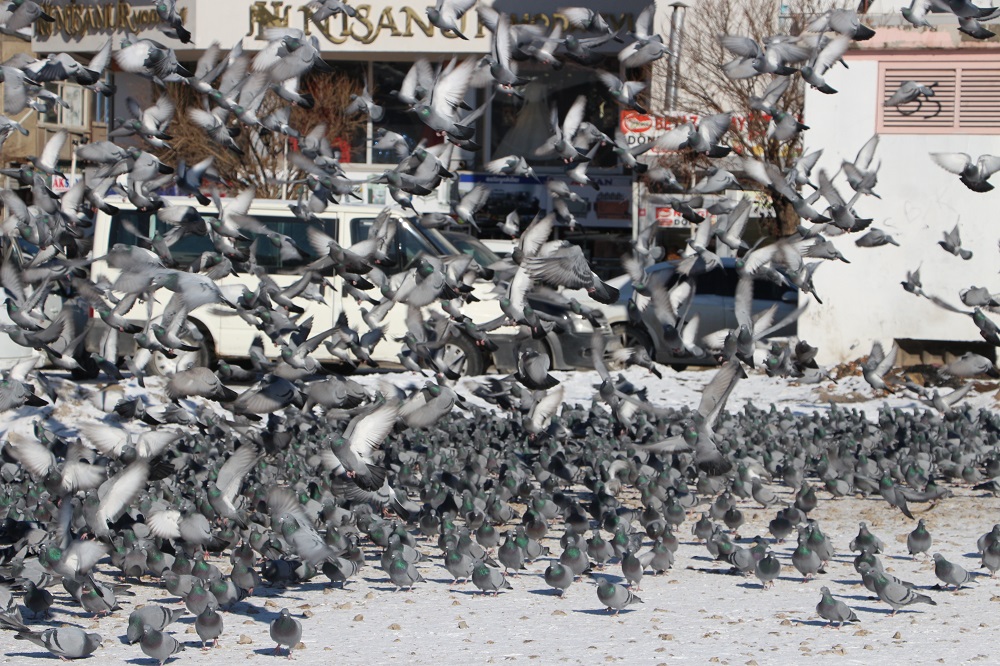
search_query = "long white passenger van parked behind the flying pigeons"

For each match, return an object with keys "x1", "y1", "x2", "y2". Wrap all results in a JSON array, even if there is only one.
[{"x1": 89, "y1": 197, "x2": 593, "y2": 375}]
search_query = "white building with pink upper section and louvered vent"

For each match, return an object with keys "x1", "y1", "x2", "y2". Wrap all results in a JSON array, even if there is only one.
[{"x1": 799, "y1": 3, "x2": 1000, "y2": 364}]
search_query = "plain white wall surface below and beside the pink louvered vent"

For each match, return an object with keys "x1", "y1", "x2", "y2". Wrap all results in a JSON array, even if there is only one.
[{"x1": 799, "y1": 54, "x2": 1000, "y2": 364}]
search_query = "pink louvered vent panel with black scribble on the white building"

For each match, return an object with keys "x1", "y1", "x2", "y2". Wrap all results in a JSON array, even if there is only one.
[{"x1": 877, "y1": 55, "x2": 1000, "y2": 134}]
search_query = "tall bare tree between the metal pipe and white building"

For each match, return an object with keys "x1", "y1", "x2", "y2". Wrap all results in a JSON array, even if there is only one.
[{"x1": 663, "y1": 0, "x2": 834, "y2": 235}]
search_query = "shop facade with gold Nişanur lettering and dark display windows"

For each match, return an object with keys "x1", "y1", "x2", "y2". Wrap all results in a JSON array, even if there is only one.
[{"x1": 33, "y1": 0, "x2": 669, "y2": 274}]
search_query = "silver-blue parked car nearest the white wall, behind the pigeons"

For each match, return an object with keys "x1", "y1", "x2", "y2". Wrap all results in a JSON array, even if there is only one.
[{"x1": 588, "y1": 258, "x2": 799, "y2": 369}]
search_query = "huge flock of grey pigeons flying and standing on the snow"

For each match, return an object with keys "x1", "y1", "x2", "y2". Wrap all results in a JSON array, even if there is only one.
[{"x1": 0, "y1": 0, "x2": 1000, "y2": 663}]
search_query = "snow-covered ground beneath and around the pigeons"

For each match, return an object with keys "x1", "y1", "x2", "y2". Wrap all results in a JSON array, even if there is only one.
[{"x1": 0, "y1": 369, "x2": 1000, "y2": 664}]
